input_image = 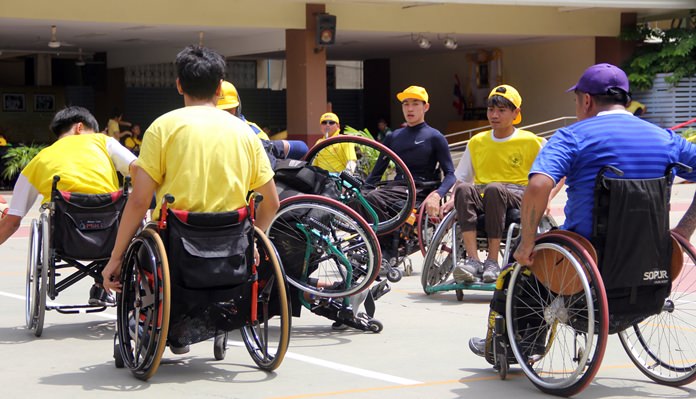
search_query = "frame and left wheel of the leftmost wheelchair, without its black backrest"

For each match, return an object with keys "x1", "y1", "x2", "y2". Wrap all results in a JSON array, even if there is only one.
[{"x1": 25, "y1": 176, "x2": 130, "y2": 337}]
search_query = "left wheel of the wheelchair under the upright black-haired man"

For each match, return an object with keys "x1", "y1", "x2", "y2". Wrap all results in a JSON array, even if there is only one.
[{"x1": 116, "y1": 228, "x2": 171, "y2": 381}]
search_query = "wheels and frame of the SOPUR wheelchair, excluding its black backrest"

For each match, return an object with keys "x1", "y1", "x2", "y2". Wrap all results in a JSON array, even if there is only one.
[{"x1": 486, "y1": 164, "x2": 696, "y2": 396}]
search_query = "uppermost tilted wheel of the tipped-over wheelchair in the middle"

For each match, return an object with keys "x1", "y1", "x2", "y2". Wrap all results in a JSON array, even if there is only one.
[{"x1": 303, "y1": 135, "x2": 416, "y2": 235}]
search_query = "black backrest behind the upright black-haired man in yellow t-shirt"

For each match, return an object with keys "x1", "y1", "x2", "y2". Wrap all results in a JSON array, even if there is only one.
[{"x1": 161, "y1": 207, "x2": 254, "y2": 289}]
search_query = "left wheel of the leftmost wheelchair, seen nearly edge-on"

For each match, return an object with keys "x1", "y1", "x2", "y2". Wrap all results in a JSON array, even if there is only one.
[{"x1": 24, "y1": 214, "x2": 50, "y2": 337}]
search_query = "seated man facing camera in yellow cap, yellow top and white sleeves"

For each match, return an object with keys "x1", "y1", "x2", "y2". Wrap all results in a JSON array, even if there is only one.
[{"x1": 444, "y1": 85, "x2": 546, "y2": 283}]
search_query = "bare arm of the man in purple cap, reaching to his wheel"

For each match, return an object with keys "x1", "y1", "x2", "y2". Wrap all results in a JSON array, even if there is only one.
[{"x1": 514, "y1": 173, "x2": 555, "y2": 265}]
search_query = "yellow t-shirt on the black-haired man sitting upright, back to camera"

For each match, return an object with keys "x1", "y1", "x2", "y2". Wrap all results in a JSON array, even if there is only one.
[{"x1": 136, "y1": 106, "x2": 273, "y2": 217}]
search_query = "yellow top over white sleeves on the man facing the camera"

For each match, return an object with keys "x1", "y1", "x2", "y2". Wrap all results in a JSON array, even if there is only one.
[{"x1": 468, "y1": 129, "x2": 544, "y2": 186}]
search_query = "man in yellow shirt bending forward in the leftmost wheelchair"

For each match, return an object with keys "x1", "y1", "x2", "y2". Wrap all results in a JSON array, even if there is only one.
[{"x1": 0, "y1": 107, "x2": 135, "y2": 306}]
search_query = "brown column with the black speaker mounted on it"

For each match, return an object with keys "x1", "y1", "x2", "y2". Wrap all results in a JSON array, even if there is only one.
[{"x1": 285, "y1": 4, "x2": 327, "y2": 147}]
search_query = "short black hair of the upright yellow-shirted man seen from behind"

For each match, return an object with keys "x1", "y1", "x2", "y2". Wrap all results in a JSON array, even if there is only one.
[{"x1": 175, "y1": 45, "x2": 226, "y2": 99}]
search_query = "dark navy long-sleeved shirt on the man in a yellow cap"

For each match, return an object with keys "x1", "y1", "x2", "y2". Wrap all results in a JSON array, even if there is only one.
[{"x1": 367, "y1": 122, "x2": 456, "y2": 197}]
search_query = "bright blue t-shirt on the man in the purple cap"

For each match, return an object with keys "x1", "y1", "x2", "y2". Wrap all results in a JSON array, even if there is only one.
[{"x1": 529, "y1": 111, "x2": 696, "y2": 238}]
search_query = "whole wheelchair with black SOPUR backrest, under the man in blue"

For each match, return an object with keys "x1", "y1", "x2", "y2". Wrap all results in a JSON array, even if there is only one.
[{"x1": 478, "y1": 164, "x2": 696, "y2": 396}]
